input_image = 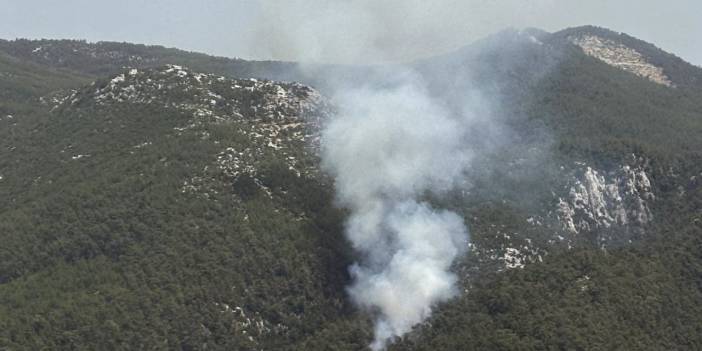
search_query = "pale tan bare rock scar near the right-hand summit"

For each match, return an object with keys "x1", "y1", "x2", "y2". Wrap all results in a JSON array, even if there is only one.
[{"x1": 568, "y1": 35, "x2": 673, "y2": 87}]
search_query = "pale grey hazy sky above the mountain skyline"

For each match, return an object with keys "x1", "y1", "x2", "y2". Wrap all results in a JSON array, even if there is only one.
[{"x1": 0, "y1": 0, "x2": 702, "y2": 65}]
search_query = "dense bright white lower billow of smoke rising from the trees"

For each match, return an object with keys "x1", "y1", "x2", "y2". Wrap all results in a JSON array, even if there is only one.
[{"x1": 349, "y1": 201, "x2": 467, "y2": 350}]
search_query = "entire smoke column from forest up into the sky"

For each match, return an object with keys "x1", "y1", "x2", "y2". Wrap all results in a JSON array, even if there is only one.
[{"x1": 253, "y1": 0, "x2": 492, "y2": 350}]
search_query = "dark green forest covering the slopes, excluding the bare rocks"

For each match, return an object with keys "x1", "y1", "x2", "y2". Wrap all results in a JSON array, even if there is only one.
[{"x1": 0, "y1": 28, "x2": 702, "y2": 350}]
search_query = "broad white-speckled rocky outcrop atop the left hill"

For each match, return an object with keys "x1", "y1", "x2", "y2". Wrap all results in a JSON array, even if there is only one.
[{"x1": 53, "y1": 65, "x2": 330, "y2": 197}]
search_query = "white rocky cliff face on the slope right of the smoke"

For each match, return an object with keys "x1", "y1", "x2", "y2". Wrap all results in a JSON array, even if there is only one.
[{"x1": 556, "y1": 161, "x2": 655, "y2": 234}]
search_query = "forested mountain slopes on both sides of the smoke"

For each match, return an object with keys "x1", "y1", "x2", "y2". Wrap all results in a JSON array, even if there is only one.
[{"x1": 0, "y1": 27, "x2": 702, "y2": 350}]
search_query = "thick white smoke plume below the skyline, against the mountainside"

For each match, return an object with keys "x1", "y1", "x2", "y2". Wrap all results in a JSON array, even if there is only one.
[{"x1": 322, "y1": 79, "x2": 478, "y2": 350}]
